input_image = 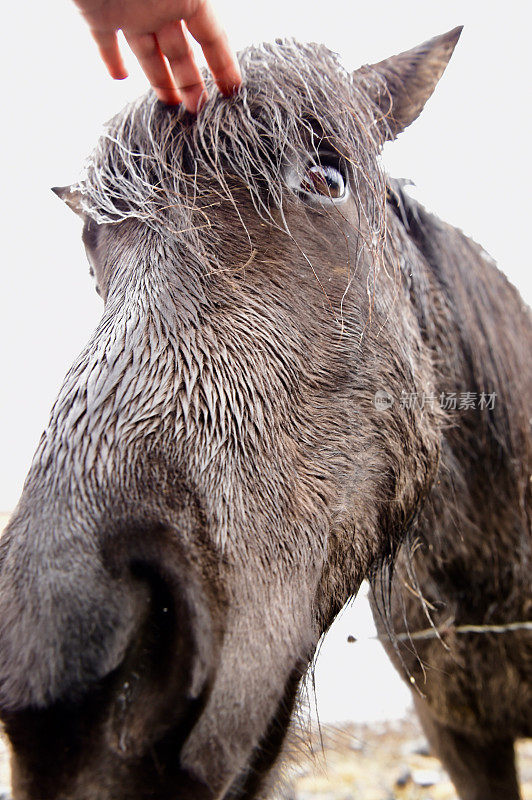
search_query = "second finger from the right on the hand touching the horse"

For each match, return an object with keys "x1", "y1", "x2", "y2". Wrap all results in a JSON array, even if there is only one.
[{"x1": 156, "y1": 21, "x2": 207, "y2": 113}]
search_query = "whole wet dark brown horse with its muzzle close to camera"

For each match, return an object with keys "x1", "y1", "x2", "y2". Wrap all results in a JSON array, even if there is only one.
[{"x1": 0, "y1": 29, "x2": 532, "y2": 800}]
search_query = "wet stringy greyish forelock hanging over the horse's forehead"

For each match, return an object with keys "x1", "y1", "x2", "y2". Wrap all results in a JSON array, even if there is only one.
[{"x1": 78, "y1": 40, "x2": 385, "y2": 269}]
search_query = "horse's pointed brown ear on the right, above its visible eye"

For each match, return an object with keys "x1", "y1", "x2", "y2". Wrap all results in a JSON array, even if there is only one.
[{"x1": 355, "y1": 26, "x2": 462, "y2": 140}]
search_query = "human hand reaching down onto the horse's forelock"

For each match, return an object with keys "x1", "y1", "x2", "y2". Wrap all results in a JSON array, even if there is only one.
[{"x1": 74, "y1": 0, "x2": 242, "y2": 113}]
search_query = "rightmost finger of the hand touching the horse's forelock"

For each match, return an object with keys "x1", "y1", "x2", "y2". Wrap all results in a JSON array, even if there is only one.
[{"x1": 186, "y1": 0, "x2": 242, "y2": 96}]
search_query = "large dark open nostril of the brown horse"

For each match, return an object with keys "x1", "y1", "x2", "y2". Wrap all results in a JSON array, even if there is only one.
[{"x1": 104, "y1": 563, "x2": 210, "y2": 756}]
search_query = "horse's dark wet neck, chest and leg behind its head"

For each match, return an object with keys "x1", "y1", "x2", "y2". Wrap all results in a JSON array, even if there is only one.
[{"x1": 373, "y1": 187, "x2": 532, "y2": 800}]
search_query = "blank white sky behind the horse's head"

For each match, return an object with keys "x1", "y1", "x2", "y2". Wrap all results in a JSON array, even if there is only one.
[{"x1": 0, "y1": 0, "x2": 532, "y2": 718}]
